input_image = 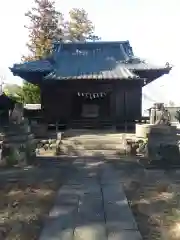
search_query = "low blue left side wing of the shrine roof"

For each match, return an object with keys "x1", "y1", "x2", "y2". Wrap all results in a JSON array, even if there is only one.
[{"x1": 11, "y1": 60, "x2": 53, "y2": 72}]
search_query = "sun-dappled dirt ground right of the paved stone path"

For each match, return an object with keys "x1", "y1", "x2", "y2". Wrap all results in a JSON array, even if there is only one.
[{"x1": 125, "y1": 170, "x2": 180, "y2": 240}]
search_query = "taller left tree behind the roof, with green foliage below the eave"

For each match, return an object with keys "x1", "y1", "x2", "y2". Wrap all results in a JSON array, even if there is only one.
[{"x1": 22, "y1": 0, "x2": 63, "y2": 103}]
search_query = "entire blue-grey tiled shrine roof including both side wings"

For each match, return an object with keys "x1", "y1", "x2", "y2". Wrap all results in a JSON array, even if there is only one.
[{"x1": 10, "y1": 41, "x2": 171, "y2": 79}]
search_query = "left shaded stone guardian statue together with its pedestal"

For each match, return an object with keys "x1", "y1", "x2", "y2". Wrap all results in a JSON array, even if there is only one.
[{"x1": 0, "y1": 104, "x2": 36, "y2": 166}]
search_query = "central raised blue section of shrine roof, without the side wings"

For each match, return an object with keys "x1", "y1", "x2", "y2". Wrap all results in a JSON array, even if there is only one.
[{"x1": 45, "y1": 41, "x2": 141, "y2": 79}]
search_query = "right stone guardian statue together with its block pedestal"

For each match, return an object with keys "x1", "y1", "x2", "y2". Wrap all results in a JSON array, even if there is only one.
[{"x1": 136, "y1": 104, "x2": 180, "y2": 164}]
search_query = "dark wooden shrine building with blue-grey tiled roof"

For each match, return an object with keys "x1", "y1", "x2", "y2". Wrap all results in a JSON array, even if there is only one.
[{"x1": 10, "y1": 41, "x2": 171, "y2": 128}]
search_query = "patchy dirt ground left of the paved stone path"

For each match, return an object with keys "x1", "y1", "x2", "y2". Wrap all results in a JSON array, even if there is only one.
[{"x1": 0, "y1": 160, "x2": 74, "y2": 240}]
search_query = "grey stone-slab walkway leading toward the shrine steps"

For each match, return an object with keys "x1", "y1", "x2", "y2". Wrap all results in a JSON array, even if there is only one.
[{"x1": 40, "y1": 159, "x2": 142, "y2": 240}]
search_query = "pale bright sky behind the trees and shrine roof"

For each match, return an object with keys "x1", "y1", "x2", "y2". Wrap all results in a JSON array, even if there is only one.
[{"x1": 0, "y1": 0, "x2": 180, "y2": 109}]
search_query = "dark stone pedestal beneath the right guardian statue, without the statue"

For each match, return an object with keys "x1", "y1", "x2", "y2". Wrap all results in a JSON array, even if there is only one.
[{"x1": 136, "y1": 124, "x2": 180, "y2": 164}]
